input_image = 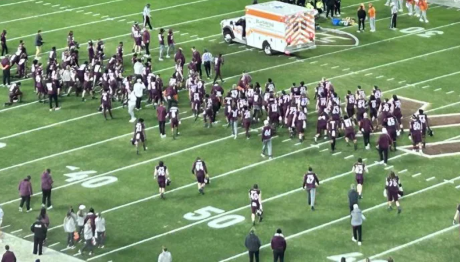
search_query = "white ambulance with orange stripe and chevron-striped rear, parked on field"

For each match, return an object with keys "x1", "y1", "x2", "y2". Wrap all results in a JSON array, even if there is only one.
[{"x1": 221, "y1": 1, "x2": 317, "y2": 55}]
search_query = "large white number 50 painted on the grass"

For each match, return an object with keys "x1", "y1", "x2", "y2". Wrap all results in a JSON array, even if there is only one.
[{"x1": 184, "y1": 206, "x2": 244, "y2": 229}]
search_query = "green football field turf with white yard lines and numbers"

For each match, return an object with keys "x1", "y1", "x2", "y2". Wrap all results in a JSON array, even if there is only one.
[{"x1": 0, "y1": 0, "x2": 460, "y2": 262}]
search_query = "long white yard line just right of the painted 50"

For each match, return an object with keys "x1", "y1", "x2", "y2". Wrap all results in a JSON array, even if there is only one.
[{"x1": 220, "y1": 176, "x2": 460, "y2": 262}]
